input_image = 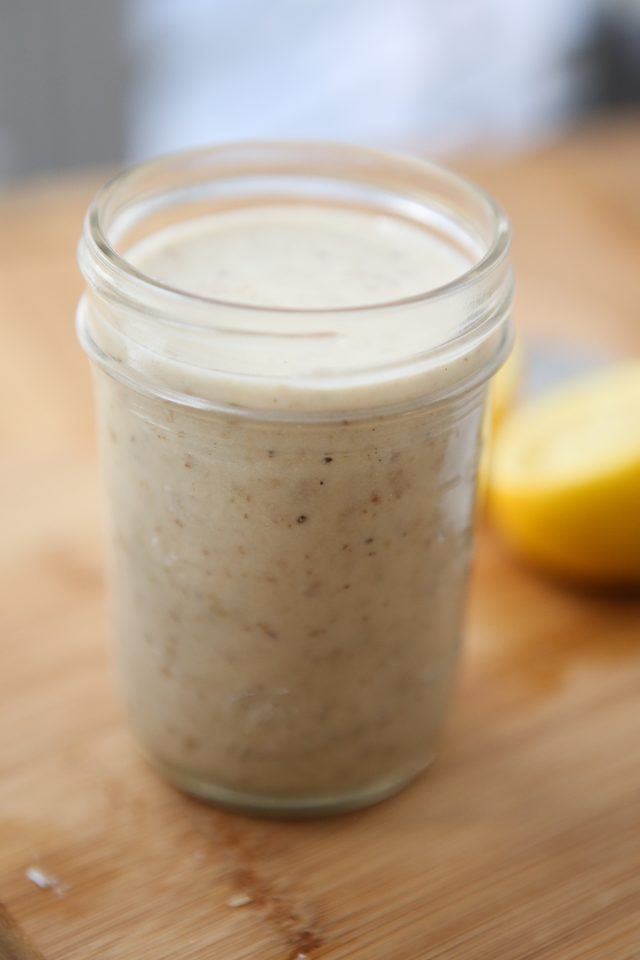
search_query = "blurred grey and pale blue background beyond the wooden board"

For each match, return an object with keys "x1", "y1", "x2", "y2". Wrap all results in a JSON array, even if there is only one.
[{"x1": 0, "y1": 0, "x2": 640, "y2": 182}]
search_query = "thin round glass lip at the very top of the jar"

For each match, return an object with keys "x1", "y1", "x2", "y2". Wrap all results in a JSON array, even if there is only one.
[{"x1": 79, "y1": 139, "x2": 511, "y2": 318}]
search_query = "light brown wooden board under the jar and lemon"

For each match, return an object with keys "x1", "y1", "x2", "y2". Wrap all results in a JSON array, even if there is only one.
[{"x1": 0, "y1": 120, "x2": 640, "y2": 960}]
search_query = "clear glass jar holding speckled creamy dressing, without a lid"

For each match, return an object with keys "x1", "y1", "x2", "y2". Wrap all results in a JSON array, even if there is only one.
[{"x1": 78, "y1": 143, "x2": 512, "y2": 816}]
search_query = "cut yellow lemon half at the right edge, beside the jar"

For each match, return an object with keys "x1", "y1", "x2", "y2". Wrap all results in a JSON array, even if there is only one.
[{"x1": 488, "y1": 361, "x2": 640, "y2": 583}]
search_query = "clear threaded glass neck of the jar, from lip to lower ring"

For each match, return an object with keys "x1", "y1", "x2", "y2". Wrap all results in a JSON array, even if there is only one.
[{"x1": 77, "y1": 140, "x2": 513, "y2": 417}]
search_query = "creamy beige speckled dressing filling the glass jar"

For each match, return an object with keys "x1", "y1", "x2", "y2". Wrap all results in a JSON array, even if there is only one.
[{"x1": 98, "y1": 204, "x2": 484, "y2": 810}]
